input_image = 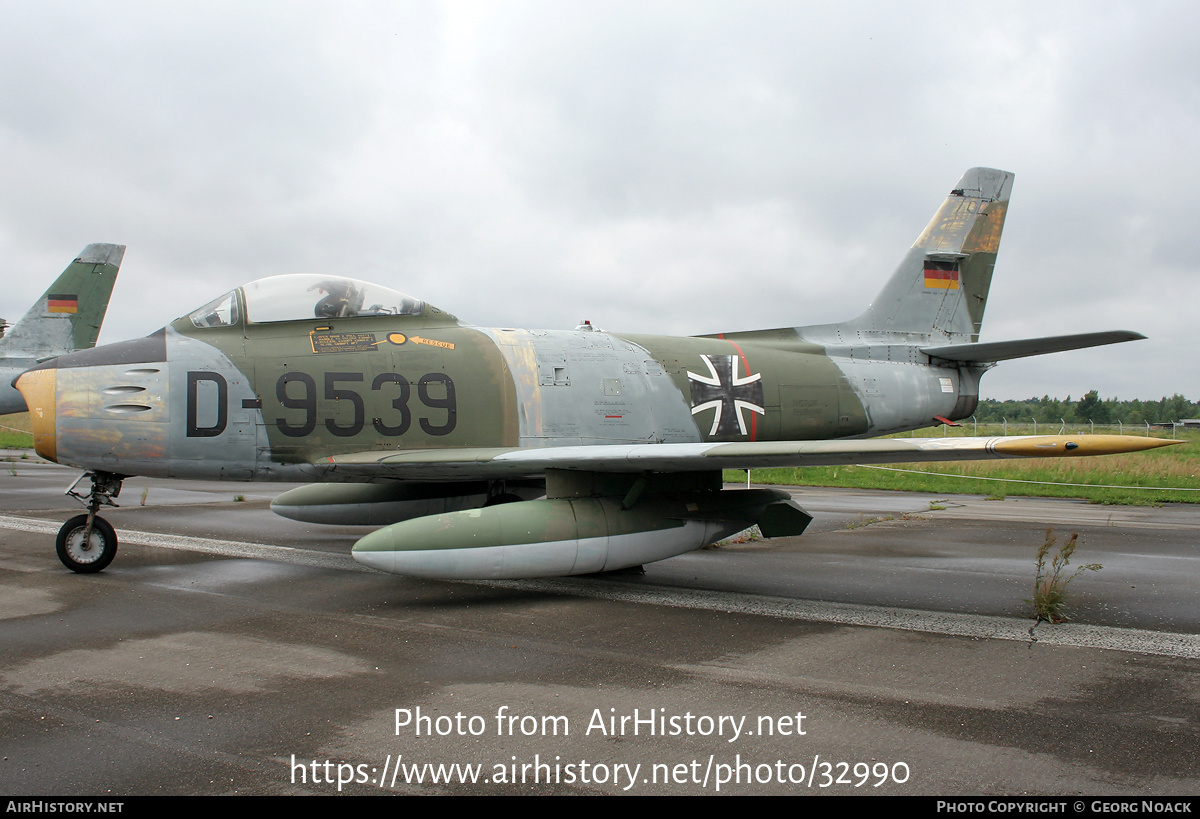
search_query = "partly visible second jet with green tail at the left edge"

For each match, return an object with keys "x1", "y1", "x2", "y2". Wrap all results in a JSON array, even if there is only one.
[{"x1": 0, "y1": 238, "x2": 125, "y2": 416}]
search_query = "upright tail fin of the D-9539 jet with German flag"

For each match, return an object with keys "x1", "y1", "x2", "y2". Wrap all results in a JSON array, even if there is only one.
[{"x1": 840, "y1": 168, "x2": 1013, "y2": 342}]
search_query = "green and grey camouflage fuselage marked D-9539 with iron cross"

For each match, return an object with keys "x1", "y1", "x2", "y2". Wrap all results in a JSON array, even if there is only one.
[{"x1": 23, "y1": 306, "x2": 976, "y2": 480}]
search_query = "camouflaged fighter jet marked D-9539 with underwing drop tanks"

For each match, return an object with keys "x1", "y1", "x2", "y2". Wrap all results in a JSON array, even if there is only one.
[{"x1": 17, "y1": 168, "x2": 1169, "y2": 578}]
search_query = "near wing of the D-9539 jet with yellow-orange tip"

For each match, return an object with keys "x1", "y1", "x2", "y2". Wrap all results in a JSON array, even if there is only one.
[{"x1": 314, "y1": 435, "x2": 1176, "y2": 480}]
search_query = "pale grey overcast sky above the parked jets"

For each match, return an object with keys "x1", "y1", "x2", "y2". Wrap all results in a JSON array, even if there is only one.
[{"x1": 0, "y1": 0, "x2": 1200, "y2": 400}]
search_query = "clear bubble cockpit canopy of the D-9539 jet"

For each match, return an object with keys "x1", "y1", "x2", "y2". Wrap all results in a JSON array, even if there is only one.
[{"x1": 188, "y1": 274, "x2": 425, "y2": 328}]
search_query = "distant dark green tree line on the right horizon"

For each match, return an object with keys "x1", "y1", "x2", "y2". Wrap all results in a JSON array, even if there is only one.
[{"x1": 974, "y1": 389, "x2": 1200, "y2": 424}]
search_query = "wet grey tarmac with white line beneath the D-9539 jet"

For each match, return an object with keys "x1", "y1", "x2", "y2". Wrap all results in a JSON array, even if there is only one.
[{"x1": 0, "y1": 456, "x2": 1200, "y2": 795}]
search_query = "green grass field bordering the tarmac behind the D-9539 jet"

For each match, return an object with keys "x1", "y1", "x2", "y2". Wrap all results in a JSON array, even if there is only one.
[{"x1": 0, "y1": 413, "x2": 1200, "y2": 504}]
